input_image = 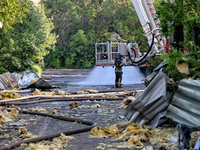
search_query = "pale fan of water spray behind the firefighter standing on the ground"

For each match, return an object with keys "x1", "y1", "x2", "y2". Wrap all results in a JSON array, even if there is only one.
[{"x1": 76, "y1": 66, "x2": 144, "y2": 85}]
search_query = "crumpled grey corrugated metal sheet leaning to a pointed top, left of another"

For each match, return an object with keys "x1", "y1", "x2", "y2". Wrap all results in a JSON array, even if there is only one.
[{"x1": 124, "y1": 71, "x2": 169, "y2": 127}]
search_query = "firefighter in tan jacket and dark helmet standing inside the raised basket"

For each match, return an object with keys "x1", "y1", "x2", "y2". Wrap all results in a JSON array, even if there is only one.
[{"x1": 109, "y1": 30, "x2": 126, "y2": 59}]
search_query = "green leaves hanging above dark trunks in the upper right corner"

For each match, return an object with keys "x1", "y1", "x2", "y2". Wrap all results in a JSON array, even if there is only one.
[{"x1": 156, "y1": 0, "x2": 200, "y2": 40}]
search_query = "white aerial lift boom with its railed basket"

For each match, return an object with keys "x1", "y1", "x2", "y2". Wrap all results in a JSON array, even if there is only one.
[{"x1": 95, "y1": 0, "x2": 169, "y2": 66}]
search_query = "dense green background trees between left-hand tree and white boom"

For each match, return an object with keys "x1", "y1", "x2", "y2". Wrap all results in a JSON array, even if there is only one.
[{"x1": 42, "y1": 0, "x2": 148, "y2": 68}]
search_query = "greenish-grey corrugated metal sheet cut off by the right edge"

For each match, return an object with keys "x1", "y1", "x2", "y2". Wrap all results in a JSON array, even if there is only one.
[{"x1": 166, "y1": 79, "x2": 200, "y2": 127}]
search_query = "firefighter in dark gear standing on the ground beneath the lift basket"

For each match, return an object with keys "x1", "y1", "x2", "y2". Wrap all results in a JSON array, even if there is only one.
[{"x1": 115, "y1": 53, "x2": 123, "y2": 88}]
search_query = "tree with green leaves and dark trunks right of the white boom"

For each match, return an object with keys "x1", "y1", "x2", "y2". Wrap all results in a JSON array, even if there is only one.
[{"x1": 157, "y1": 0, "x2": 200, "y2": 50}]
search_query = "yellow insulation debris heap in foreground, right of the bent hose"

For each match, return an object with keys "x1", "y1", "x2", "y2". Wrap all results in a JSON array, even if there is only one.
[{"x1": 90, "y1": 123, "x2": 178, "y2": 149}]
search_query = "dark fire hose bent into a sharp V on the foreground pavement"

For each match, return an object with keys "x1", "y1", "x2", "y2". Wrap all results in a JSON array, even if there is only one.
[{"x1": 0, "y1": 110, "x2": 96, "y2": 150}]
